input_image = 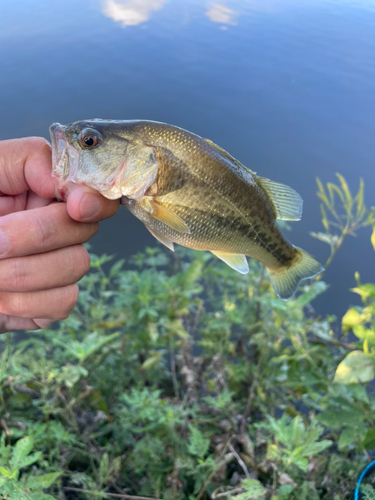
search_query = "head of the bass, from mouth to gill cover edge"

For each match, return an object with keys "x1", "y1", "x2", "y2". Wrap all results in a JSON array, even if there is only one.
[{"x1": 50, "y1": 120, "x2": 158, "y2": 200}]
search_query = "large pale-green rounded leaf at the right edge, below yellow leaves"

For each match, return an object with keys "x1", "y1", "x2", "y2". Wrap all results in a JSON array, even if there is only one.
[{"x1": 333, "y1": 351, "x2": 375, "y2": 384}]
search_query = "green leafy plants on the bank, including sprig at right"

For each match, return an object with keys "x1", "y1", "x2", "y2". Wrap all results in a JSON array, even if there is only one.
[{"x1": 0, "y1": 173, "x2": 375, "y2": 500}]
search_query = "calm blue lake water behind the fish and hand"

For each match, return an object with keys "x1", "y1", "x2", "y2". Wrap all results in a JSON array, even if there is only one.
[{"x1": 0, "y1": 0, "x2": 375, "y2": 315}]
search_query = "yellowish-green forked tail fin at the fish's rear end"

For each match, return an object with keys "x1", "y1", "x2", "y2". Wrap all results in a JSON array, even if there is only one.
[{"x1": 267, "y1": 248, "x2": 324, "y2": 300}]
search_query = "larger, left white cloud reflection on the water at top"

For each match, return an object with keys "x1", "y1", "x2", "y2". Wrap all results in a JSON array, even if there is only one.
[{"x1": 102, "y1": 0, "x2": 168, "y2": 28}]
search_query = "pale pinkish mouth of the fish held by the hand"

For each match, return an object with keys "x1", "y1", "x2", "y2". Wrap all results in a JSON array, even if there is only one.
[{"x1": 49, "y1": 123, "x2": 79, "y2": 201}]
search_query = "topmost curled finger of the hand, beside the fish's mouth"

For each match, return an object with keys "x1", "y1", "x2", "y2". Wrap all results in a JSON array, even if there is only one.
[{"x1": 0, "y1": 137, "x2": 55, "y2": 199}]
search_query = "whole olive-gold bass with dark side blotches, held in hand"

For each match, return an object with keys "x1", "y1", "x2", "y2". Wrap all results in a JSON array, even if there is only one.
[{"x1": 50, "y1": 119, "x2": 324, "y2": 300}]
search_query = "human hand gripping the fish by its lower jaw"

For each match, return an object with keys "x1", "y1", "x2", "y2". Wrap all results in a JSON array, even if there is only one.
[{"x1": 0, "y1": 137, "x2": 119, "y2": 333}]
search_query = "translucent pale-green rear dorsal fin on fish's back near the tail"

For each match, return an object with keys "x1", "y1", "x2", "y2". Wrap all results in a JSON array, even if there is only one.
[{"x1": 256, "y1": 177, "x2": 303, "y2": 220}]
